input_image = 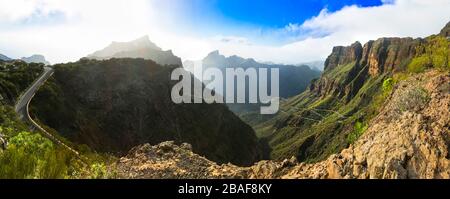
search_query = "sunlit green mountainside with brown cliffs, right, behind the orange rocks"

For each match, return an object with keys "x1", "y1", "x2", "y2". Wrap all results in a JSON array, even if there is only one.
[{"x1": 246, "y1": 22, "x2": 450, "y2": 162}]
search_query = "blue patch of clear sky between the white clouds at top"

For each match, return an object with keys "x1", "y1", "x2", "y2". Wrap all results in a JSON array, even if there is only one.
[{"x1": 155, "y1": 0, "x2": 383, "y2": 45}]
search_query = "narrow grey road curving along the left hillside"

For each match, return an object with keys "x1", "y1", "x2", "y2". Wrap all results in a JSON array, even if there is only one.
[{"x1": 14, "y1": 66, "x2": 80, "y2": 157}]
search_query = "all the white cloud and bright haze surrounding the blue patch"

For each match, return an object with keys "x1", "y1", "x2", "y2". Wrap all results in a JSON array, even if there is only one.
[{"x1": 0, "y1": 0, "x2": 450, "y2": 63}]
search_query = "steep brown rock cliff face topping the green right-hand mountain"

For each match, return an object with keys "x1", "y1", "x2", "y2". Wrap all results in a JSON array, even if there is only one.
[{"x1": 310, "y1": 38, "x2": 423, "y2": 100}]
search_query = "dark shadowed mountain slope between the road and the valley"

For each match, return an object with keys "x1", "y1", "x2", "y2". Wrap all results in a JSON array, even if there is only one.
[{"x1": 31, "y1": 58, "x2": 262, "y2": 165}]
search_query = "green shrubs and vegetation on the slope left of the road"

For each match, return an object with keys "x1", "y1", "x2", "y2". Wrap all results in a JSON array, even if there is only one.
[{"x1": 0, "y1": 61, "x2": 115, "y2": 179}]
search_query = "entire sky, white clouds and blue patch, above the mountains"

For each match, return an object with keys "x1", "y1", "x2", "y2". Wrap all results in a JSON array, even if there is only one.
[{"x1": 0, "y1": 0, "x2": 450, "y2": 64}]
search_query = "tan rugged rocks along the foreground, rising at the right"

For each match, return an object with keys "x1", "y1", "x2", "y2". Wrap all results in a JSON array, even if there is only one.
[{"x1": 114, "y1": 71, "x2": 450, "y2": 179}]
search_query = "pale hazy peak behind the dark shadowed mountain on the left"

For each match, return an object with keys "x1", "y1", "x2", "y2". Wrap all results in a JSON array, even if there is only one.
[{"x1": 87, "y1": 36, "x2": 182, "y2": 66}]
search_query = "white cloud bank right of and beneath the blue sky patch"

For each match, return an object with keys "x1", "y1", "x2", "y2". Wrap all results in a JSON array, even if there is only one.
[{"x1": 211, "y1": 0, "x2": 450, "y2": 64}]
